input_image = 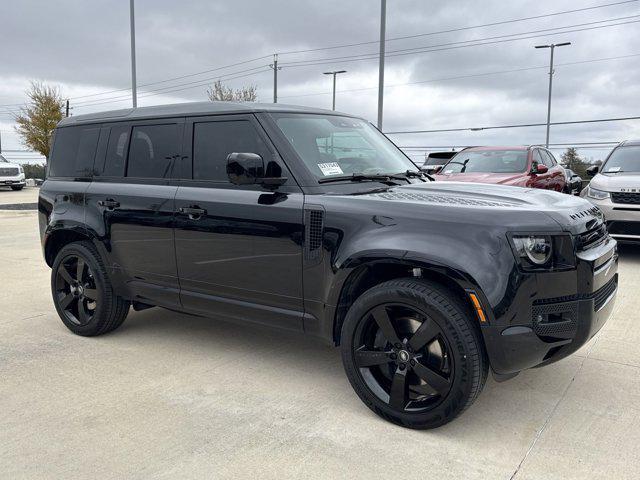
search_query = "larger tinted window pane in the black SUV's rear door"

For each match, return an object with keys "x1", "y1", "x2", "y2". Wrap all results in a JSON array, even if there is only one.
[{"x1": 127, "y1": 124, "x2": 180, "y2": 178}]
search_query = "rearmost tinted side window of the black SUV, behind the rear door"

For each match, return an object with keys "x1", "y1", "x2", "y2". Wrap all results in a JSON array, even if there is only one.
[{"x1": 49, "y1": 127, "x2": 100, "y2": 177}]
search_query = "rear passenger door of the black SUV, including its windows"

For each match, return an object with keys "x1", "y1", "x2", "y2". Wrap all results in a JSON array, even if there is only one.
[{"x1": 87, "y1": 118, "x2": 184, "y2": 307}]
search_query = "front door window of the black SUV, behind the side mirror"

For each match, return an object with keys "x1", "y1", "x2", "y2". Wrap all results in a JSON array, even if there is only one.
[{"x1": 193, "y1": 120, "x2": 271, "y2": 182}]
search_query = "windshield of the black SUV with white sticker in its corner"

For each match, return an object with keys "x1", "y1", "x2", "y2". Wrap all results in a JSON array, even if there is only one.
[{"x1": 273, "y1": 114, "x2": 418, "y2": 179}]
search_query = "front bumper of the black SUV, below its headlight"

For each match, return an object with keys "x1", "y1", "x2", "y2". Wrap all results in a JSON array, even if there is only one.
[{"x1": 482, "y1": 239, "x2": 618, "y2": 375}]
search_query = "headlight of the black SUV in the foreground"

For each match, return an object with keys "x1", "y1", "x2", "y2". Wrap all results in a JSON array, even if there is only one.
[{"x1": 510, "y1": 233, "x2": 575, "y2": 271}]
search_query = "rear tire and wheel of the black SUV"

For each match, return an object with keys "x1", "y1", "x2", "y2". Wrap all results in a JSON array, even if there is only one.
[{"x1": 51, "y1": 242, "x2": 130, "y2": 337}]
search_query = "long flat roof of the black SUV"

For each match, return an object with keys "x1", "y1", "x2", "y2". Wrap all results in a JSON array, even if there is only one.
[{"x1": 58, "y1": 102, "x2": 351, "y2": 127}]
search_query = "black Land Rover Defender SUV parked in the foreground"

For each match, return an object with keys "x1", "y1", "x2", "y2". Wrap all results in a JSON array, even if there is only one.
[{"x1": 38, "y1": 103, "x2": 618, "y2": 428}]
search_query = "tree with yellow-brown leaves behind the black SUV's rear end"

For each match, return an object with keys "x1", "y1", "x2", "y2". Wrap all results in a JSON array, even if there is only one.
[{"x1": 15, "y1": 81, "x2": 64, "y2": 159}]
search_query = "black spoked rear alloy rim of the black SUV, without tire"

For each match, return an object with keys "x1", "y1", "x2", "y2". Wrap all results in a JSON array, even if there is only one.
[{"x1": 55, "y1": 255, "x2": 98, "y2": 326}]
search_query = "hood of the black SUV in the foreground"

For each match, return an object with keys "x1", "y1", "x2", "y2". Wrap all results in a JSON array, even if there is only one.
[{"x1": 340, "y1": 181, "x2": 603, "y2": 233}]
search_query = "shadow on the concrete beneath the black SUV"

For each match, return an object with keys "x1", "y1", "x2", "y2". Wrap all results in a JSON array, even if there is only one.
[{"x1": 110, "y1": 308, "x2": 581, "y2": 436}]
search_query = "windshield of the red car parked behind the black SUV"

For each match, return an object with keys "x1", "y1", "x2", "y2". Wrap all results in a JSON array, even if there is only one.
[{"x1": 443, "y1": 150, "x2": 528, "y2": 173}]
